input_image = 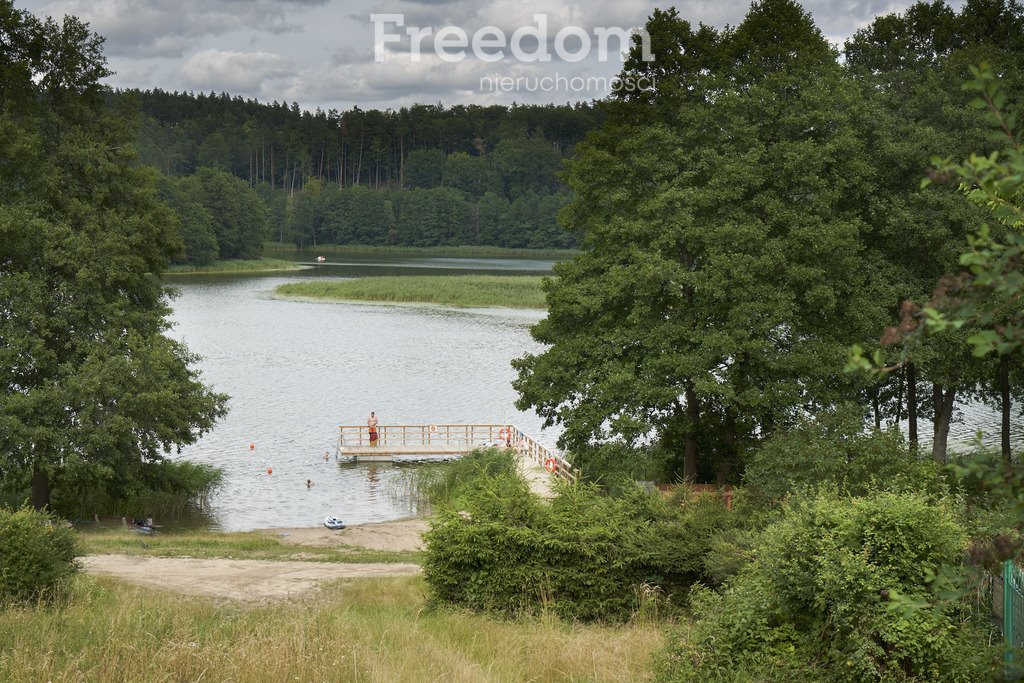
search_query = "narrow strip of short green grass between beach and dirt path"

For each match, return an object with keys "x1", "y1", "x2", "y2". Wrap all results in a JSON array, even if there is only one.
[{"x1": 79, "y1": 529, "x2": 422, "y2": 563}]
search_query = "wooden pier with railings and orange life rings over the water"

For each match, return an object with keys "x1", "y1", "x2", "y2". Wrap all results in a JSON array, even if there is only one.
[{"x1": 337, "y1": 425, "x2": 578, "y2": 481}]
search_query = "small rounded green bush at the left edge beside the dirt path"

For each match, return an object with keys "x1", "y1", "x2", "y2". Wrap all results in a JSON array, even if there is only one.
[{"x1": 0, "y1": 508, "x2": 79, "y2": 603}]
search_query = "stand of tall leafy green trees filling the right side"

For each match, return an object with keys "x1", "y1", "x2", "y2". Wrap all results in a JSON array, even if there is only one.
[{"x1": 516, "y1": 0, "x2": 1024, "y2": 481}]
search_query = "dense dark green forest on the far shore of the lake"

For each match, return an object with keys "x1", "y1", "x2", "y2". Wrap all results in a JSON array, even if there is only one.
[{"x1": 124, "y1": 90, "x2": 603, "y2": 260}]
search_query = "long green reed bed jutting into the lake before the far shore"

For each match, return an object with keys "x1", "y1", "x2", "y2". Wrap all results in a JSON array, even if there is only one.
[{"x1": 274, "y1": 275, "x2": 547, "y2": 308}]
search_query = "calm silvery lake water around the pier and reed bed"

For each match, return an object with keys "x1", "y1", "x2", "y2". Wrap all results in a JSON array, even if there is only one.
[{"x1": 163, "y1": 254, "x2": 1024, "y2": 530}]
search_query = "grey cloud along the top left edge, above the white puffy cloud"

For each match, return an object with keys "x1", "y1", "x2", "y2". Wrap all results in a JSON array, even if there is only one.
[{"x1": 42, "y1": 0, "x2": 329, "y2": 57}]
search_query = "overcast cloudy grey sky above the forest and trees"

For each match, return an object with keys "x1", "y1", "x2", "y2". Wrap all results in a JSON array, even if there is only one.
[{"x1": 15, "y1": 0, "x2": 925, "y2": 111}]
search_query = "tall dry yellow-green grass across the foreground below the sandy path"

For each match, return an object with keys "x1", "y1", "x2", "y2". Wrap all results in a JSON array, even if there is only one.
[{"x1": 0, "y1": 577, "x2": 663, "y2": 682}]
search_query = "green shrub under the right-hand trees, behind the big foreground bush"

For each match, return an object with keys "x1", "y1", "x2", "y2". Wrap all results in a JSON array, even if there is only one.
[{"x1": 743, "y1": 412, "x2": 941, "y2": 501}]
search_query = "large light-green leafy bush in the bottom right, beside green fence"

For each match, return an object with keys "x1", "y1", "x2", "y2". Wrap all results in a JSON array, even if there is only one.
[{"x1": 659, "y1": 493, "x2": 997, "y2": 681}]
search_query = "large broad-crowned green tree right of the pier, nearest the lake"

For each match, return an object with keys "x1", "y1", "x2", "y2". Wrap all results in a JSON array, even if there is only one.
[{"x1": 515, "y1": 0, "x2": 885, "y2": 479}]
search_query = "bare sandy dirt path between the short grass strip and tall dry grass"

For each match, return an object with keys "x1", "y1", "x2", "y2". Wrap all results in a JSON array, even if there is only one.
[{"x1": 82, "y1": 555, "x2": 420, "y2": 602}]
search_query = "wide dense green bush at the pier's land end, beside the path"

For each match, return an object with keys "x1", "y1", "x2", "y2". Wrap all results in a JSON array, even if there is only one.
[{"x1": 424, "y1": 474, "x2": 731, "y2": 621}]
